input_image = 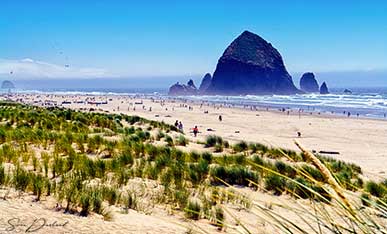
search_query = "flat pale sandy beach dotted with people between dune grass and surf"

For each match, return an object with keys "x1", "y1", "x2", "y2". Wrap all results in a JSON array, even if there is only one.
[{"x1": 3, "y1": 94, "x2": 387, "y2": 178}]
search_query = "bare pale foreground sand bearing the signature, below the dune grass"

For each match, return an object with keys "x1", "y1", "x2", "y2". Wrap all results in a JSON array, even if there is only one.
[{"x1": 0, "y1": 192, "x2": 187, "y2": 233}]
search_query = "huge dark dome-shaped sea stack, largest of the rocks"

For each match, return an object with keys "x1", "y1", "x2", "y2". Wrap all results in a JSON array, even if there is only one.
[{"x1": 206, "y1": 31, "x2": 301, "y2": 95}]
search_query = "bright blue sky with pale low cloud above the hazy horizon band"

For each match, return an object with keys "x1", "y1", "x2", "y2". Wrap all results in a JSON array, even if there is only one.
[{"x1": 0, "y1": 0, "x2": 387, "y2": 77}]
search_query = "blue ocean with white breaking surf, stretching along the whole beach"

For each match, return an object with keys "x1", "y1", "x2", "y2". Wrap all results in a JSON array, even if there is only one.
[{"x1": 2, "y1": 87, "x2": 387, "y2": 119}]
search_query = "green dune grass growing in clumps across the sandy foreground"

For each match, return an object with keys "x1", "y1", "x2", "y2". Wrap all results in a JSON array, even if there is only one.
[{"x1": 0, "y1": 103, "x2": 387, "y2": 232}]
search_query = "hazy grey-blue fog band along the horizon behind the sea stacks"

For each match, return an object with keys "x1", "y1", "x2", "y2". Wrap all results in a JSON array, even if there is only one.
[{"x1": 0, "y1": 67, "x2": 387, "y2": 90}]
